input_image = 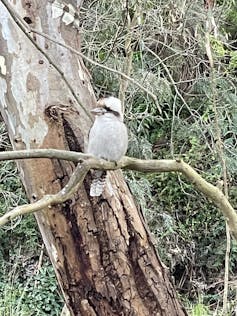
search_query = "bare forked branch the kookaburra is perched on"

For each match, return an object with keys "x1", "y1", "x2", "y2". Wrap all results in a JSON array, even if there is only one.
[{"x1": 0, "y1": 149, "x2": 237, "y2": 240}]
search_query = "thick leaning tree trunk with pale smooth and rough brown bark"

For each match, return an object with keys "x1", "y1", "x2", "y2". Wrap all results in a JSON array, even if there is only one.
[{"x1": 0, "y1": 0, "x2": 186, "y2": 316}]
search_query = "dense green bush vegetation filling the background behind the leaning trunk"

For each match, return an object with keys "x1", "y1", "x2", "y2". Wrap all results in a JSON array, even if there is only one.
[{"x1": 0, "y1": 0, "x2": 237, "y2": 316}]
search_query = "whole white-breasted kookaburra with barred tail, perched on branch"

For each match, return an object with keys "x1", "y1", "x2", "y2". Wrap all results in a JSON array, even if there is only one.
[{"x1": 87, "y1": 97, "x2": 128, "y2": 196}]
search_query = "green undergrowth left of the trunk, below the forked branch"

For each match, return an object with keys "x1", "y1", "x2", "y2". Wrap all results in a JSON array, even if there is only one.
[{"x1": 0, "y1": 212, "x2": 63, "y2": 316}]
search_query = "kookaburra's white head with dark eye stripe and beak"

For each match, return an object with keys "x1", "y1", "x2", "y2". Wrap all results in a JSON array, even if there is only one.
[{"x1": 91, "y1": 97, "x2": 123, "y2": 119}]
